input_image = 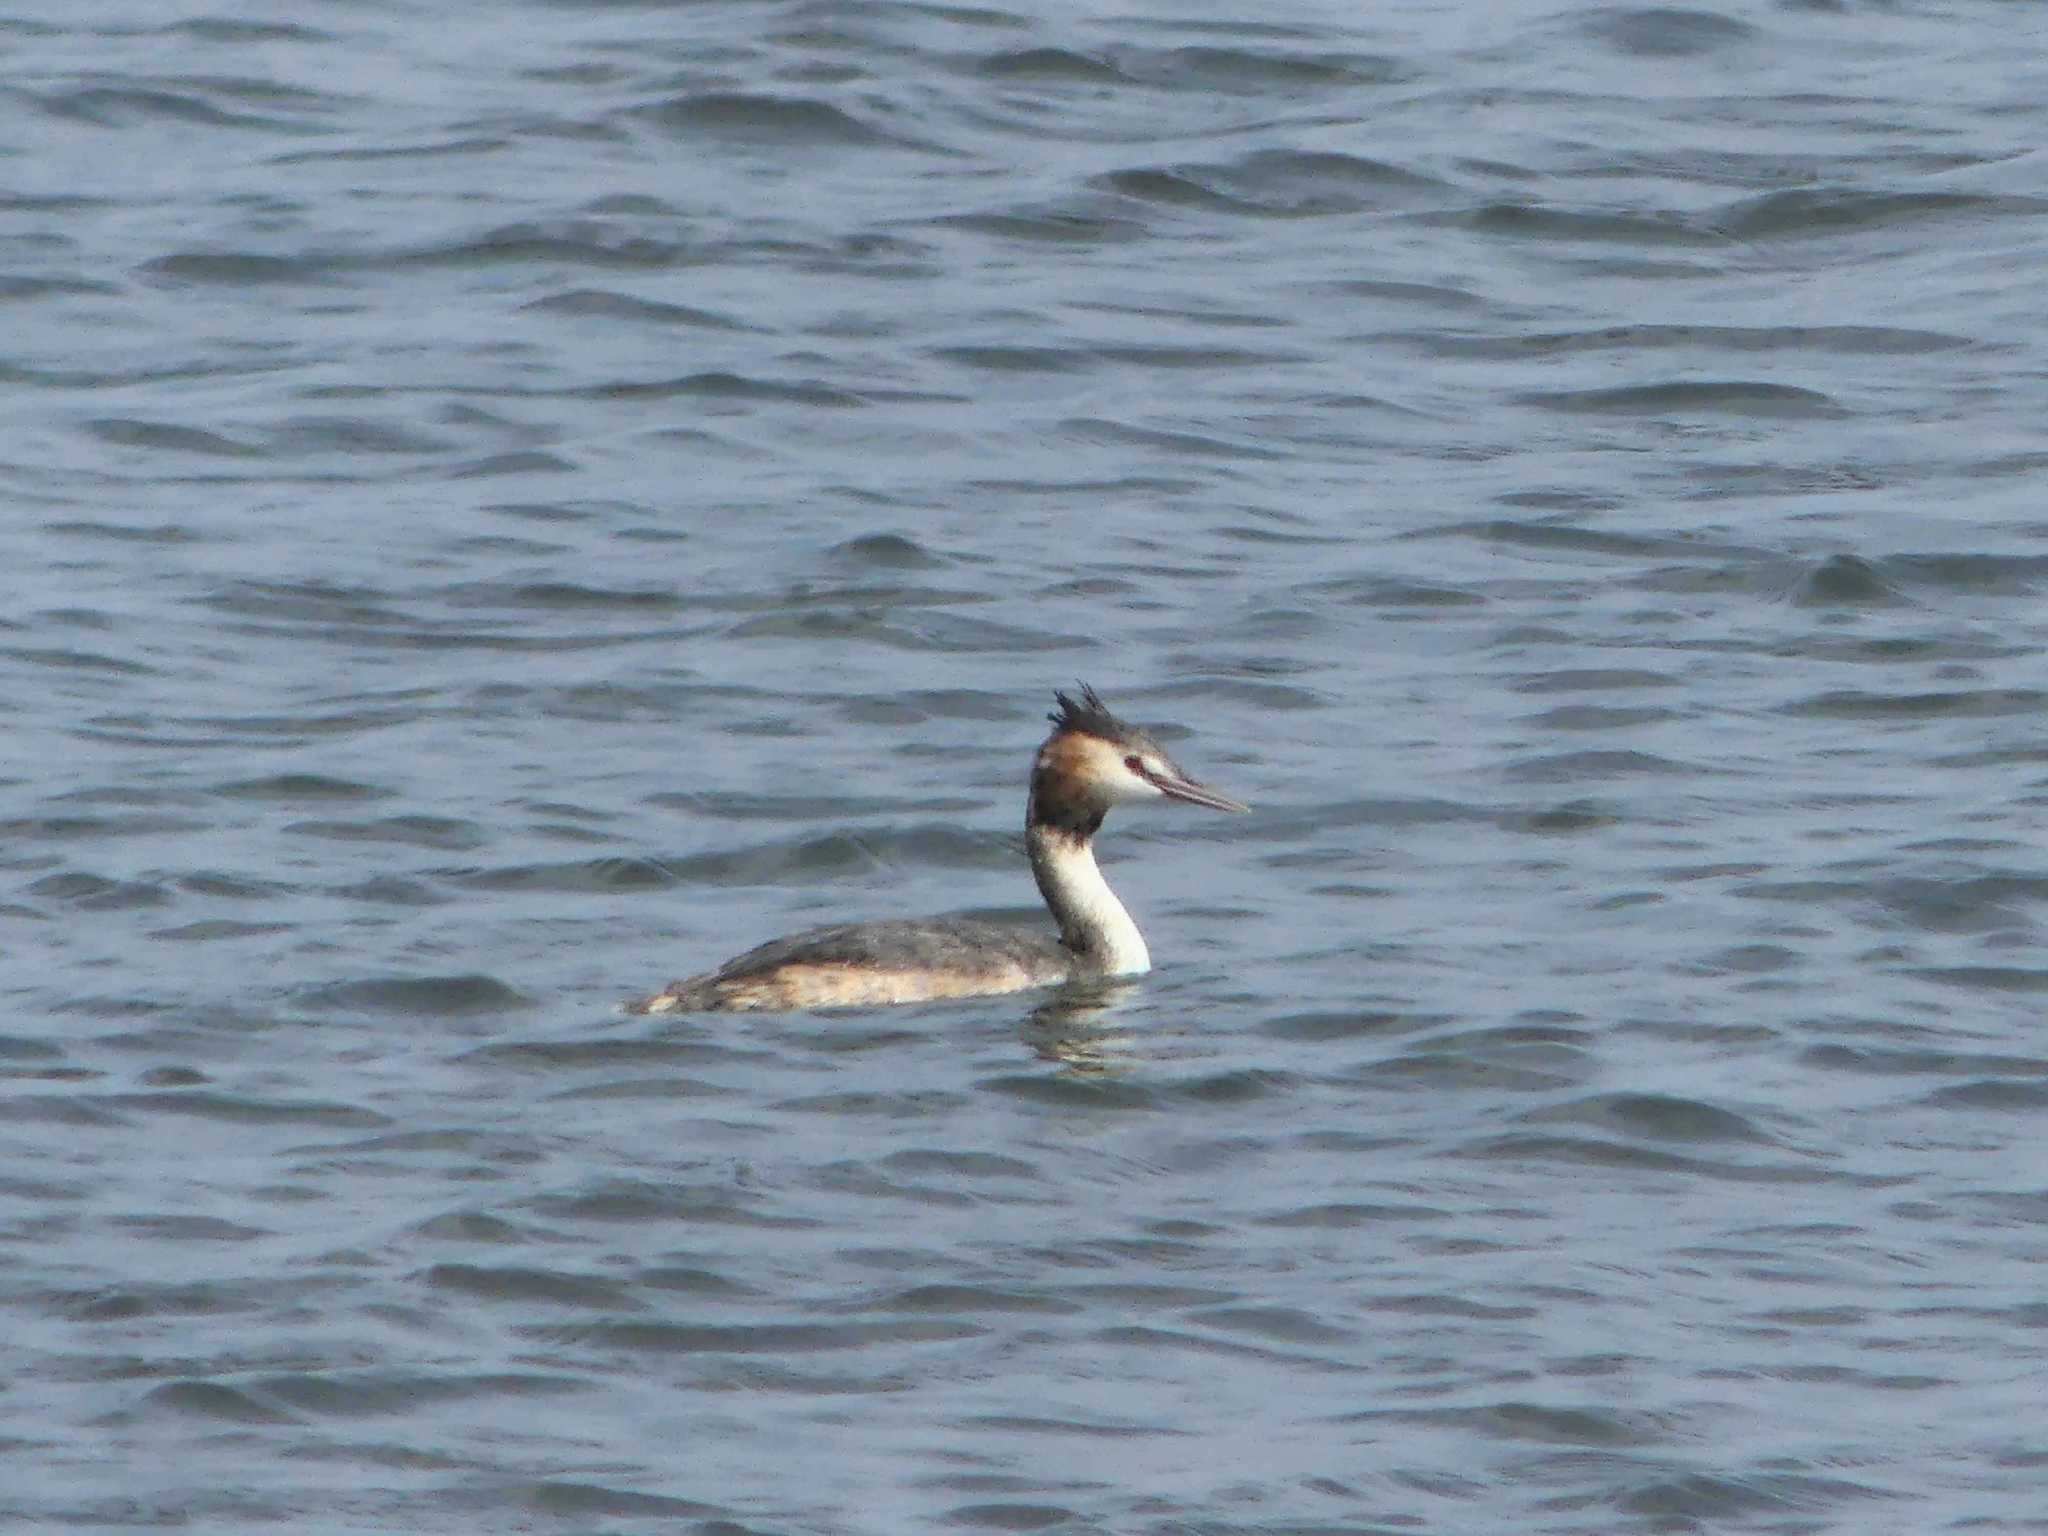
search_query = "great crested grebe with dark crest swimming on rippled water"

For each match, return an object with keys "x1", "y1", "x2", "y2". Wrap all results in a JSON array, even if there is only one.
[{"x1": 627, "y1": 684, "x2": 1249, "y2": 1014}]
